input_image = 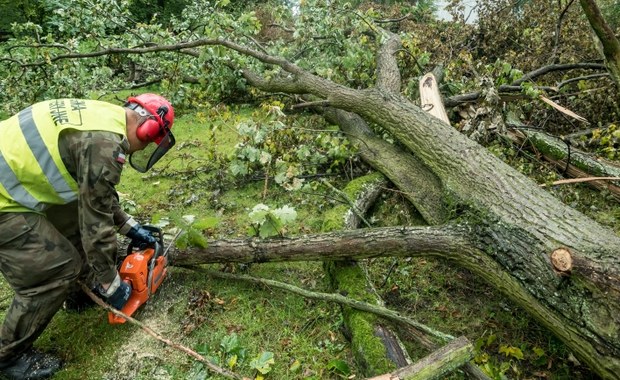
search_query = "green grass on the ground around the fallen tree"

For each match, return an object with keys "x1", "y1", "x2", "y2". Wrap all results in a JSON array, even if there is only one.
[{"x1": 0, "y1": 101, "x2": 617, "y2": 380}]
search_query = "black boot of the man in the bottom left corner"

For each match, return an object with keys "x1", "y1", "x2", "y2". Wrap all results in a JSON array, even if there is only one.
[{"x1": 0, "y1": 349, "x2": 61, "y2": 380}]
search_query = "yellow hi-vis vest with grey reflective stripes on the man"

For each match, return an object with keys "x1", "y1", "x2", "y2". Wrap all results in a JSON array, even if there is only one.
[{"x1": 0, "y1": 99, "x2": 127, "y2": 212}]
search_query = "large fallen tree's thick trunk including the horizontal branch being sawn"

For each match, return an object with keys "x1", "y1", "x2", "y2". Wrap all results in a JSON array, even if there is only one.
[{"x1": 165, "y1": 30, "x2": 620, "y2": 378}]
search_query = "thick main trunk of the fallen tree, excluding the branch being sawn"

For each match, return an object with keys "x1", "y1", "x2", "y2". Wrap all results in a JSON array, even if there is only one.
[{"x1": 226, "y1": 35, "x2": 620, "y2": 379}]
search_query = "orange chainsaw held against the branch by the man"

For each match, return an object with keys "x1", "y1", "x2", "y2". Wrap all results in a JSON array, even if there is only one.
[{"x1": 108, "y1": 225, "x2": 172, "y2": 324}]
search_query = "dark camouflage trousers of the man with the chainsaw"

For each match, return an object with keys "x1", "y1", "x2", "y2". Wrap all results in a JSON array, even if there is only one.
[{"x1": 0, "y1": 204, "x2": 86, "y2": 362}]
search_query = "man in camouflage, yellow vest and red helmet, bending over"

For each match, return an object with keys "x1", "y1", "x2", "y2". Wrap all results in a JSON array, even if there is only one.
[{"x1": 0, "y1": 94, "x2": 174, "y2": 379}]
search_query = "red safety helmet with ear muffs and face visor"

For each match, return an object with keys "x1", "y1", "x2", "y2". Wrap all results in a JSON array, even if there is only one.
[{"x1": 125, "y1": 93, "x2": 175, "y2": 173}]
